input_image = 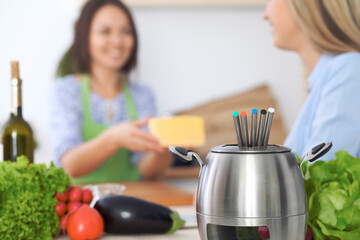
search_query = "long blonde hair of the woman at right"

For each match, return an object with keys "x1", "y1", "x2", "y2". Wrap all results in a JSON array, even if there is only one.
[{"x1": 288, "y1": 0, "x2": 360, "y2": 54}]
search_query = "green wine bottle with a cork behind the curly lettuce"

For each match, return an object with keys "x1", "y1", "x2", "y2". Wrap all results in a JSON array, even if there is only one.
[{"x1": 1, "y1": 61, "x2": 34, "y2": 163}]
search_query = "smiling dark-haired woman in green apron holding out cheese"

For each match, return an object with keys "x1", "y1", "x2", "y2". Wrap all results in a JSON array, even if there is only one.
[{"x1": 51, "y1": 0, "x2": 171, "y2": 183}]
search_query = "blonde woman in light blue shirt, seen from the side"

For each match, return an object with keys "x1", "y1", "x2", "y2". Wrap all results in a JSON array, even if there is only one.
[{"x1": 264, "y1": 0, "x2": 360, "y2": 160}]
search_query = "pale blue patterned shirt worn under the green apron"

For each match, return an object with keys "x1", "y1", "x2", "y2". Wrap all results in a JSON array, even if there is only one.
[{"x1": 50, "y1": 75, "x2": 157, "y2": 167}]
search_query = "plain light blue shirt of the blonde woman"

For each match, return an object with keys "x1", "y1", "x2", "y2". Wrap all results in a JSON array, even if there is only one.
[{"x1": 284, "y1": 52, "x2": 360, "y2": 161}]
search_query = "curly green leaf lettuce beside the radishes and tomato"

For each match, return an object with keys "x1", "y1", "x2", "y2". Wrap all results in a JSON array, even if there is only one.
[{"x1": 0, "y1": 156, "x2": 70, "y2": 240}]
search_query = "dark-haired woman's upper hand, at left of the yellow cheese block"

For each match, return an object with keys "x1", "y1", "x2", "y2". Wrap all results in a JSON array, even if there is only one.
[{"x1": 106, "y1": 118, "x2": 163, "y2": 153}]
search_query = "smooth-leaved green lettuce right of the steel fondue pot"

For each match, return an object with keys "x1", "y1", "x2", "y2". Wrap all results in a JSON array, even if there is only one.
[{"x1": 302, "y1": 151, "x2": 360, "y2": 240}]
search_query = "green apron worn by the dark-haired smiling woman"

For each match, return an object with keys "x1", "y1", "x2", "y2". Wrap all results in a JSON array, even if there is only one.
[{"x1": 71, "y1": 74, "x2": 140, "y2": 184}]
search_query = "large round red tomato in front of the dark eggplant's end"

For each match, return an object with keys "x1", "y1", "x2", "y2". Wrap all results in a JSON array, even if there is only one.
[{"x1": 66, "y1": 204, "x2": 104, "y2": 240}]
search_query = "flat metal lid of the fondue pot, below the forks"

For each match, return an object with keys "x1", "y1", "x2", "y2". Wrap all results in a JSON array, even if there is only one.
[{"x1": 211, "y1": 144, "x2": 291, "y2": 154}]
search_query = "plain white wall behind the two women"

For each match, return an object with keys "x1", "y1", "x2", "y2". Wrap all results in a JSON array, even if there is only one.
[{"x1": 0, "y1": 0, "x2": 304, "y2": 163}]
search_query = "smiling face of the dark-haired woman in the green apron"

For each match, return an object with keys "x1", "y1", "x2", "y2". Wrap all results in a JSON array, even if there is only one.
[{"x1": 89, "y1": 4, "x2": 135, "y2": 70}]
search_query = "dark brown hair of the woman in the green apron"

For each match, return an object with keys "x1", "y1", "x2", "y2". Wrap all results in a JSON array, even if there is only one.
[{"x1": 58, "y1": 0, "x2": 138, "y2": 75}]
